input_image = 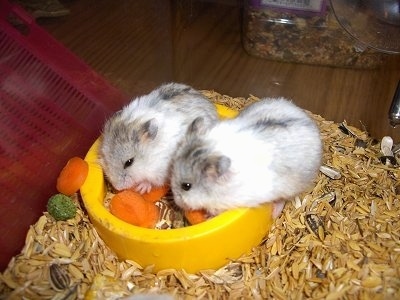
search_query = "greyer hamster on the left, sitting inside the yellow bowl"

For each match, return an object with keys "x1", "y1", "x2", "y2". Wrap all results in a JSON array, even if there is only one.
[{"x1": 99, "y1": 83, "x2": 218, "y2": 193}]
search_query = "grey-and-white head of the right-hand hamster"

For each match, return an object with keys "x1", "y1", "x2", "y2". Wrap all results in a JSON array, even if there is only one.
[{"x1": 171, "y1": 117, "x2": 231, "y2": 214}]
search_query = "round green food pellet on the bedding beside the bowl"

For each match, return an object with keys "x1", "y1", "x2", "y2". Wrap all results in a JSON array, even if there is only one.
[{"x1": 47, "y1": 194, "x2": 76, "y2": 221}]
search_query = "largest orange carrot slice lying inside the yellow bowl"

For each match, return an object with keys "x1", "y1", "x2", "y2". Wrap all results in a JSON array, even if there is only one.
[{"x1": 110, "y1": 190, "x2": 160, "y2": 228}]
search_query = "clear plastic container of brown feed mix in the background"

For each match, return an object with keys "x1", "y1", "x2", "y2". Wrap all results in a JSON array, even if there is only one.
[{"x1": 243, "y1": 0, "x2": 385, "y2": 68}]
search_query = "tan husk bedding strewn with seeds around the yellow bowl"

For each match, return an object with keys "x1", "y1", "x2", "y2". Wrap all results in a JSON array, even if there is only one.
[{"x1": 0, "y1": 91, "x2": 400, "y2": 299}]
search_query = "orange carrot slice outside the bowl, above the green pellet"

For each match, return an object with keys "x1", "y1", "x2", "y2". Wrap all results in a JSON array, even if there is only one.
[{"x1": 56, "y1": 156, "x2": 89, "y2": 196}]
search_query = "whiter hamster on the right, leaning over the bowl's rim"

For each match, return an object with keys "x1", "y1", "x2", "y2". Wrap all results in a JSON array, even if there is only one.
[{"x1": 171, "y1": 98, "x2": 322, "y2": 217}]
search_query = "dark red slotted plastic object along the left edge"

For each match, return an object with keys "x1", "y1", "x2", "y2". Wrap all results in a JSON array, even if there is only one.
[{"x1": 0, "y1": 0, "x2": 127, "y2": 270}]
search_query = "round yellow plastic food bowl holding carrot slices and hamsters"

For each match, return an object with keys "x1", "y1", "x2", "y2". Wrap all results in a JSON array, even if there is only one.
[{"x1": 80, "y1": 105, "x2": 272, "y2": 273}]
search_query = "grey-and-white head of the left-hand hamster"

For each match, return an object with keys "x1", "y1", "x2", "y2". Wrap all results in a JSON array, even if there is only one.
[{"x1": 99, "y1": 112, "x2": 163, "y2": 192}]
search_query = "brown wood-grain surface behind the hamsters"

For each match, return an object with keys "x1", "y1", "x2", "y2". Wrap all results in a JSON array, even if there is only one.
[{"x1": 38, "y1": 0, "x2": 400, "y2": 142}]
